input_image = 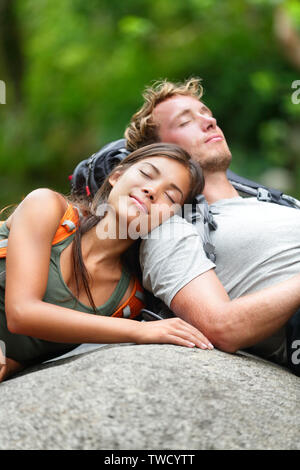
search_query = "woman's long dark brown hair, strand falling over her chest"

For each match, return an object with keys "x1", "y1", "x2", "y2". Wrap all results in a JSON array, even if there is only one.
[{"x1": 70, "y1": 142, "x2": 204, "y2": 311}]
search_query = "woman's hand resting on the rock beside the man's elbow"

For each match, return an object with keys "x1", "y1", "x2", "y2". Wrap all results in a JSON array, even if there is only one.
[{"x1": 136, "y1": 317, "x2": 213, "y2": 349}]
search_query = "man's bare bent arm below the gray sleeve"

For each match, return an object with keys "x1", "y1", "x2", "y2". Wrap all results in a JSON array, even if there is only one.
[{"x1": 170, "y1": 270, "x2": 300, "y2": 352}]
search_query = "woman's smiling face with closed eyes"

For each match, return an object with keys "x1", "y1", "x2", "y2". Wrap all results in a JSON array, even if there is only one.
[{"x1": 108, "y1": 157, "x2": 190, "y2": 238}]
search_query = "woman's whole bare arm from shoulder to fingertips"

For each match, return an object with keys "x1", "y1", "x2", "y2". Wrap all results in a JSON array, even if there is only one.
[{"x1": 5, "y1": 189, "x2": 209, "y2": 347}]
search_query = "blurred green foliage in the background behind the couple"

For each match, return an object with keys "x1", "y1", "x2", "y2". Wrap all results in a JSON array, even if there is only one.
[{"x1": 0, "y1": 0, "x2": 300, "y2": 206}]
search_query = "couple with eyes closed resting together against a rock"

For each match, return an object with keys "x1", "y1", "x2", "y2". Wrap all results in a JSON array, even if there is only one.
[{"x1": 0, "y1": 78, "x2": 300, "y2": 380}]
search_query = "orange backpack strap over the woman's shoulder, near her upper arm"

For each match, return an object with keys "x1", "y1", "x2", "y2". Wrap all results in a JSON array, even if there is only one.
[{"x1": 0, "y1": 204, "x2": 79, "y2": 258}]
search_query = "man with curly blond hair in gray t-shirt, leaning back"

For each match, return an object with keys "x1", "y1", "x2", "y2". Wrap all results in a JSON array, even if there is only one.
[{"x1": 125, "y1": 79, "x2": 300, "y2": 370}]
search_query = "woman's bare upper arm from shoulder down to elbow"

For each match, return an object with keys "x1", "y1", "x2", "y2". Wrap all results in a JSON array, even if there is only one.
[{"x1": 5, "y1": 189, "x2": 67, "y2": 330}]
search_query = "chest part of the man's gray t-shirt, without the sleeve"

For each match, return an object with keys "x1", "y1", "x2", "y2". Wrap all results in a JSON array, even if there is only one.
[{"x1": 210, "y1": 197, "x2": 300, "y2": 299}]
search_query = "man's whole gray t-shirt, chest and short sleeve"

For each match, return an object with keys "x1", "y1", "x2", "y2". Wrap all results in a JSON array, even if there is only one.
[{"x1": 140, "y1": 197, "x2": 300, "y2": 363}]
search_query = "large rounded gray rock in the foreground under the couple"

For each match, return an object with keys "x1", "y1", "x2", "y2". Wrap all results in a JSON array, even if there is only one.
[{"x1": 0, "y1": 344, "x2": 300, "y2": 450}]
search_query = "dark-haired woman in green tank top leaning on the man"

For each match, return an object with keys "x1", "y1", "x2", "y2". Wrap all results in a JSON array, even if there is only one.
[{"x1": 0, "y1": 144, "x2": 209, "y2": 380}]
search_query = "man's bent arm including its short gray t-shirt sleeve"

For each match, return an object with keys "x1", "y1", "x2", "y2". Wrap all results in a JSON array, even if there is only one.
[{"x1": 140, "y1": 216, "x2": 300, "y2": 352}]
